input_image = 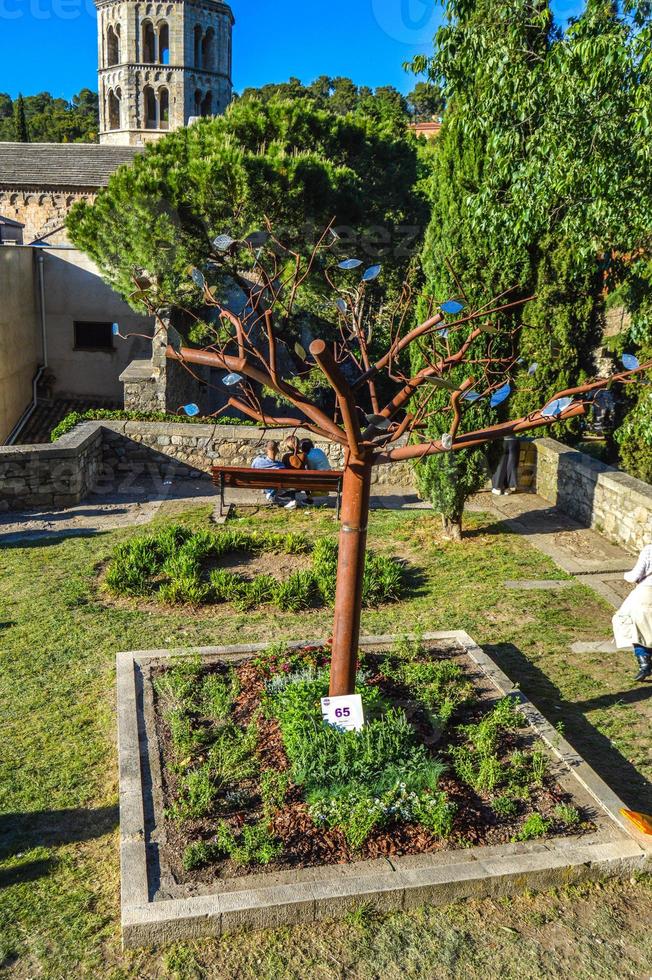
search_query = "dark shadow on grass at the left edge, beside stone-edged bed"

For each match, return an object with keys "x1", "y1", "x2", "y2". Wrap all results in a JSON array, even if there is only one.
[{"x1": 0, "y1": 808, "x2": 119, "y2": 870}]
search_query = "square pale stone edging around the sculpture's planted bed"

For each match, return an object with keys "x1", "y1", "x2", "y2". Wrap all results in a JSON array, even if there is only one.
[{"x1": 117, "y1": 631, "x2": 652, "y2": 947}]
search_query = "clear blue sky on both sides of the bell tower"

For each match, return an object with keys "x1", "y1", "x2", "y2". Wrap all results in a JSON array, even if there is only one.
[{"x1": 0, "y1": 0, "x2": 578, "y2": 98}]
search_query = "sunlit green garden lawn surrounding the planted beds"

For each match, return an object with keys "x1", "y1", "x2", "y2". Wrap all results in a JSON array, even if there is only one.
[{"x1": 0, "y1": 508, "x2": 652, "y2": 980}]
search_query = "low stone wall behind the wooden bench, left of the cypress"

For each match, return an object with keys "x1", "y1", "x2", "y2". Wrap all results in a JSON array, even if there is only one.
[{"x1": 0, "y1": 420, "x2": 414, "y2": 511}]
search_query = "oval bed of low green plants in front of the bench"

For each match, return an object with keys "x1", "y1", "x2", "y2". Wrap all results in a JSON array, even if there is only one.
[{"x1": 104, "y1": 524, "x2": 405, "y2": 612}]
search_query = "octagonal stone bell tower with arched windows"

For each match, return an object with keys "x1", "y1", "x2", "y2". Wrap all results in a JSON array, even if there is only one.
[{"x1": 95, "y1": 0, "x2": 235, "y2": 146}]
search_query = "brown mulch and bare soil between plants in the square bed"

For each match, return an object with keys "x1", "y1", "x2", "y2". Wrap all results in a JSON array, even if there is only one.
[{"x1": 153, "y1": 649, "x2": 594, "y2": 885}]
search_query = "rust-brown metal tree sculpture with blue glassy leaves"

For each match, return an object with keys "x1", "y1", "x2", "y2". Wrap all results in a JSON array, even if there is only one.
[{"x1": 129, "y1": 228, "x2": 652, "y2": 696}]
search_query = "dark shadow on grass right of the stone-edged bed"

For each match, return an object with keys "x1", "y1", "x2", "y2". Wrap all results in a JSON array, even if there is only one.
[{"x1": 483, "y1": 643, "x2": 652, "y2": 812}]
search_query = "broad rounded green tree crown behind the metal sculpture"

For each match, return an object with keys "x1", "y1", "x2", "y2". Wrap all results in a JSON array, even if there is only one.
[{"x1": 68, "y1": 98, "x2": 426, "y2": 332}]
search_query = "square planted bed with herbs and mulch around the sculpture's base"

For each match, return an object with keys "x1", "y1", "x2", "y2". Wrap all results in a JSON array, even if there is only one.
[{"x1": 154, "y1": 643, "x2": 590, "y2": 883}]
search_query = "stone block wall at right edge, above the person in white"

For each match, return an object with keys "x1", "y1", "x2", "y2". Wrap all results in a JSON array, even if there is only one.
[{"x1": 536, "y1": 439, "x2": 652, "y2": 552}]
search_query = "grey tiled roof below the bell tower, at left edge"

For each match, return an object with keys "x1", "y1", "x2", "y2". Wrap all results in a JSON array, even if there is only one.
[{"x1": 0, "y1": 143, "x2": 142, "y2": 188}]
